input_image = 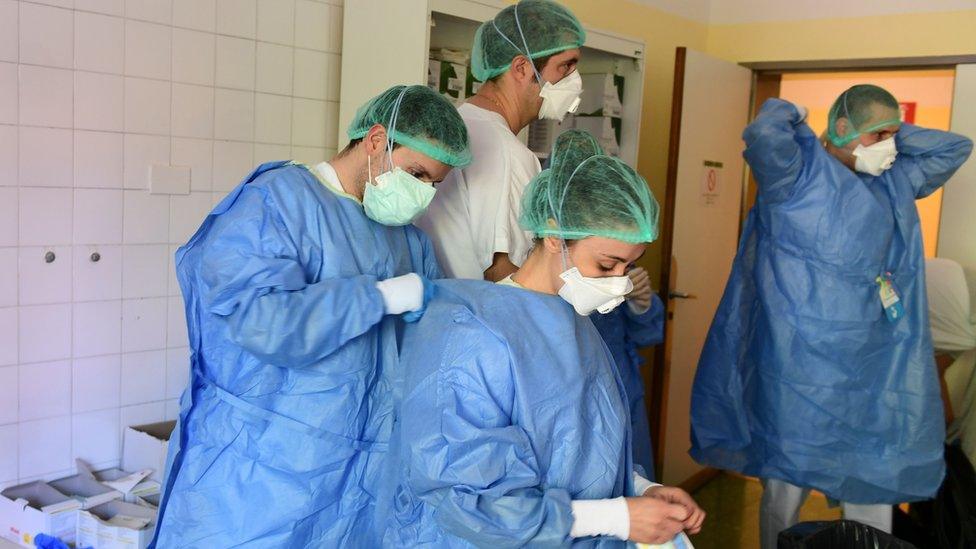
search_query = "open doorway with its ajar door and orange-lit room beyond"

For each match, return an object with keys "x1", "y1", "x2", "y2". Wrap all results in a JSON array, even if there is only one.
[{"x1": 645, "y1": 48, "x2": 976, "y2": 488}]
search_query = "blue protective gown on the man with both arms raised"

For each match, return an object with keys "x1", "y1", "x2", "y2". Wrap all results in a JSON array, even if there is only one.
[{"x1": 691, "y1": 99, "x2": 972, "y2": 504}]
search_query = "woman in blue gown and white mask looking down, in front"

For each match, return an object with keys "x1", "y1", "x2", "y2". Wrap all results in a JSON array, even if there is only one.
[{"x1": 380, "y1": 130, "x2": 704, "y2": 547}]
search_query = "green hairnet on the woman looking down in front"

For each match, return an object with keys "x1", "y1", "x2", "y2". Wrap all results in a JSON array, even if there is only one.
[{"x1": 519, "y1": 130, "x2": 659, "y2": 244}]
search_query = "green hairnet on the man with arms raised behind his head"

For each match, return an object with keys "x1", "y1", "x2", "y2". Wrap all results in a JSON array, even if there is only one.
[{"x1": 827, "y1": 84, "x2": 901, "y2": 147}]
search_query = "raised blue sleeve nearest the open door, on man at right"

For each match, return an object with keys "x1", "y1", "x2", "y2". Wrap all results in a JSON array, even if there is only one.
[{"x1": 742, "y1": 99, "x2": 803, "y2": 203}]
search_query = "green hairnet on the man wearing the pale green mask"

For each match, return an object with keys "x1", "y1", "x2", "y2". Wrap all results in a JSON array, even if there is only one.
[{"x1": 346, "y1": 85, "x2": 471, "y2": 167}]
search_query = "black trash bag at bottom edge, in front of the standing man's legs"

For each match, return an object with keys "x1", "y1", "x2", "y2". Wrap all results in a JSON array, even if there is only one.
[{"x1": 777, "y1": 520, "x2": 915, "y2": 549}]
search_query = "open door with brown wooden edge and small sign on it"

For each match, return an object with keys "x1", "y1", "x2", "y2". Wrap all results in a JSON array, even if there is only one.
[{"x1": 658, "y1": 48, "x2": 752, "y2": 485}]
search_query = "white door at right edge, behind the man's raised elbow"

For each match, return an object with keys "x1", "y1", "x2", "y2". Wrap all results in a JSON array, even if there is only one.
[{"x1": 938, "y1": 65, "x2": 976, "y2": 269}]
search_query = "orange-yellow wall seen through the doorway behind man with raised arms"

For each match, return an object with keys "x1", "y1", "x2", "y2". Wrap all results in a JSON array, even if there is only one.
[{"x1": 780, "y1": 69, "x2": 955, "y2": 257}]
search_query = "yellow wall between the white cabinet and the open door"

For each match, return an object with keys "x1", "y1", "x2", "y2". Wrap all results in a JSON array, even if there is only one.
[{"x1": 560, "y1": 0, "x2": 708, "y2": 281}]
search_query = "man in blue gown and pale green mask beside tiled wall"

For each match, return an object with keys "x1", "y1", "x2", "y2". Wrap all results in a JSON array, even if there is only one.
[{"x1": 156, "y1": 86, "x2": 470, "y2": 548}]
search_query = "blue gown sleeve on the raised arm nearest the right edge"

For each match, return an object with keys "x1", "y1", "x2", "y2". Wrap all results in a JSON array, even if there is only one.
[{"x1": 892, "y1": 124, "x2": 973, "y2": 198}]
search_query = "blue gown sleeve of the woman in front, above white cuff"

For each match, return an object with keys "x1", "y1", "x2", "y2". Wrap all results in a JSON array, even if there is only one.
[{"x1": 401, "y1": 325, "x2": 573, "y2": 547}]
